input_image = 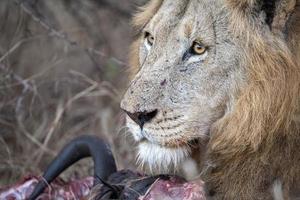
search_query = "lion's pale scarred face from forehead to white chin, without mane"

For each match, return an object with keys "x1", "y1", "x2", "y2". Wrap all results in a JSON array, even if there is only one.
[{"x1": 121, "y1": 0, "x2": 244, "y2": 173}]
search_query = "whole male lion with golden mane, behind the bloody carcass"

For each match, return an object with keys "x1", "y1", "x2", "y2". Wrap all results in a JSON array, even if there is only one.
[{"x1": 121, "y1": 0, "x2": 300, "y2": 200}]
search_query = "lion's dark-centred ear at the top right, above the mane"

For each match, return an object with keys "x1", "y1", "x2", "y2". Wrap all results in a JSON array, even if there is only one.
[{"x1": 227, "y1": 0, "x2": 300, "y2": 32}]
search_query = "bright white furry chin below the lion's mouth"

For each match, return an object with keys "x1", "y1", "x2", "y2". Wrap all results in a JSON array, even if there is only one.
[{"x1": 137, "y1": 141, "x2": 191, "y2": 175}]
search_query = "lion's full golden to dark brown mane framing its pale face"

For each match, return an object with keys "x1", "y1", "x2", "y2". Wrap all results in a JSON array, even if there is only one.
[{"x1": 126, "y1": 0, "x2": 300, "y2": 199}]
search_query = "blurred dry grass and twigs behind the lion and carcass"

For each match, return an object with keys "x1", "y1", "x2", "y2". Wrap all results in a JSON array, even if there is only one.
[{"x1": 0, "y1": 0, "x2": 147, "y2": 187}]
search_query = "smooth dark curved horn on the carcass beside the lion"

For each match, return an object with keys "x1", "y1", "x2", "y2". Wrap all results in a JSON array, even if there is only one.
[{"x1": 29, "y1": 136, "x2": 117, "y2": 200}]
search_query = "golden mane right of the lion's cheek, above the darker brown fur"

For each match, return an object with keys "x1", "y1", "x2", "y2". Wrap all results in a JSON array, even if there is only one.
[{"x1": 211, "y1": 0, "x2": 300, "y2": 151}]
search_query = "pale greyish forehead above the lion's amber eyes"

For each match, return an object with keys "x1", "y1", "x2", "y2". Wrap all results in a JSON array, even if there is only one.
[{"x1": 147, "y1": 0, "x2": 221, "y2": 43}]
